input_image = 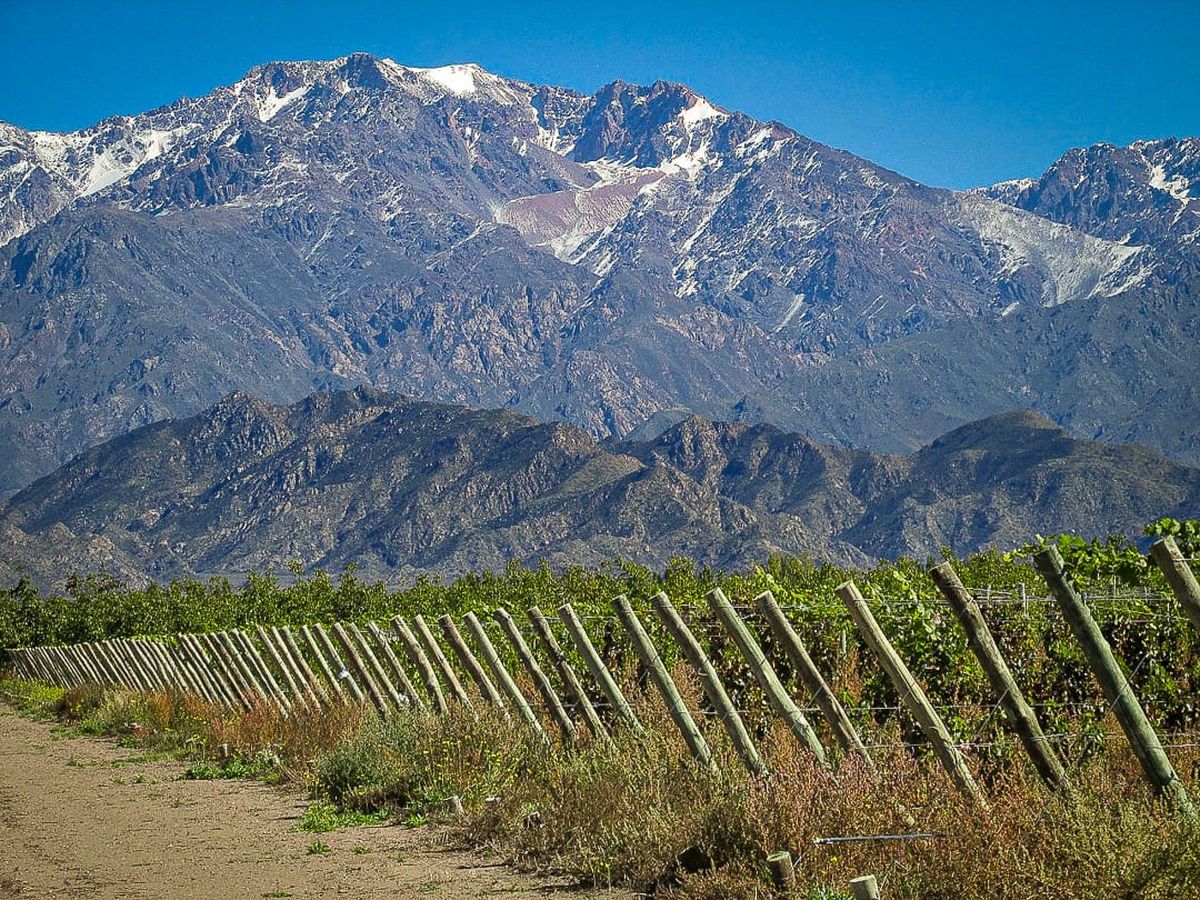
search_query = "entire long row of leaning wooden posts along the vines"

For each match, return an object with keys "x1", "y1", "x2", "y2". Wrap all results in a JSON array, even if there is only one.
[{"x1": 10, "y1": 538, "x2": 1200, "y2": 817}]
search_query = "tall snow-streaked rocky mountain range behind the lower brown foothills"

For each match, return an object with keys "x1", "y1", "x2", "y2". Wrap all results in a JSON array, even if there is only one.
[{"x1": 0, "y1": 54, "x2": 1200, "y2": 496}]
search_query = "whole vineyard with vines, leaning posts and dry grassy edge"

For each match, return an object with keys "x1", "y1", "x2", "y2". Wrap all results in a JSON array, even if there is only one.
[{"x1": 0, "y1": 520, "x2": 1200, "y2": 896}]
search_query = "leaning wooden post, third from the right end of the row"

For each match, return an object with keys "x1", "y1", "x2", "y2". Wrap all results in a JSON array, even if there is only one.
[{"x1": 929, "y1": 563, "x2": 1067, "y2": 790}]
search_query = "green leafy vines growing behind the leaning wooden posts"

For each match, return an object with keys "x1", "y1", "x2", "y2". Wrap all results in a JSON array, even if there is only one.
[{"x1": 7, "y1": 520, "x2": 1200, "y2": 764}]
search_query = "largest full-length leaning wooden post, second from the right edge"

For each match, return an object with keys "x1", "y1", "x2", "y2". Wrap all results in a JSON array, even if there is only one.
[{"x1": 1033, "y1": 547, "x2": 1196, "y2": 820}]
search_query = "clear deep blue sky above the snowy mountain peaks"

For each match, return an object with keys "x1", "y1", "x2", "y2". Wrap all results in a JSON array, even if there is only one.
[{"x1": 0, "y1": 0, "x2": 1200, "y2": 187}]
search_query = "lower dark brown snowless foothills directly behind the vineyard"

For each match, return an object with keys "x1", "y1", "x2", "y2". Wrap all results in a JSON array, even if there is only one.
[{"x1": 0, "y1": 388, "x2": 1200, "y2": 592}]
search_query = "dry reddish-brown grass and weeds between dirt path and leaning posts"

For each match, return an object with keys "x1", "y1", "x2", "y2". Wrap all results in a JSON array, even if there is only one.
[{"x1": 9, "y1": 679, "x2": 1200, "y2": 900}]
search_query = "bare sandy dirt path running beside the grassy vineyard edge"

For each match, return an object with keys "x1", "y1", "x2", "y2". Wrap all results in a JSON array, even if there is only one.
[{"x1": 0, "y1": 706, "x2": 628, "y2": 900}]
